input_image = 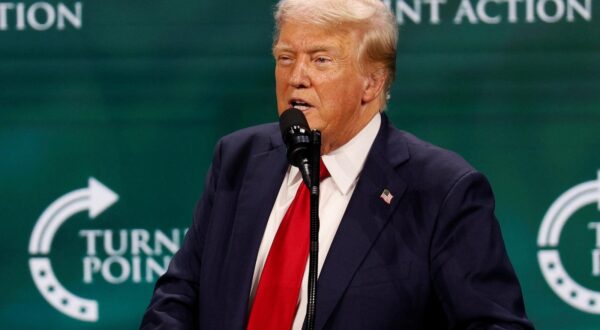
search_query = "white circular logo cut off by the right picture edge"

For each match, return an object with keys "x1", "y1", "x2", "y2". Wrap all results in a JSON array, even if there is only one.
[{"x1": 537, "y1": 171, "x2": 600, "y2": 314}]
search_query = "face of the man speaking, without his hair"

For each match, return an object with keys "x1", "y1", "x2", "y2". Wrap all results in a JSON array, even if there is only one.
[{"x1": 273, "y1": 22, "x2": 379, "y2": 154}]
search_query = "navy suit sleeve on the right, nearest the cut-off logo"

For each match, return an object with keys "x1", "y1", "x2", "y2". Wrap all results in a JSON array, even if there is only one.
[{"x1": 431, "y1": 171, "x2": 533, "y2": 329}]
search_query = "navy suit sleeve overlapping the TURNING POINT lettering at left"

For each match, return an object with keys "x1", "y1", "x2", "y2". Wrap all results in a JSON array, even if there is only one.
[{"x1": 140, "y1": 143, "x2": 221, "y2": 330}]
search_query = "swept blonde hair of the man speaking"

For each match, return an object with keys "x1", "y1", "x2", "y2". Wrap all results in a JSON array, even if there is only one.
[{"x1": 274, "y1": 0, "x2": 398, "y2": 110}]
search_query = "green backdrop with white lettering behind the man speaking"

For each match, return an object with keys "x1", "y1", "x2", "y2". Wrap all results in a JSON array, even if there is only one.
[{"x1": 0, "y1": 0, "x2": 600, "y2": 330}]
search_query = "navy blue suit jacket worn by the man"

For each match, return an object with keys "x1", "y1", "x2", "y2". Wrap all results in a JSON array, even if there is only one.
[{"x1": 142, "y1": 115, "x2": 533, "y2": 330}]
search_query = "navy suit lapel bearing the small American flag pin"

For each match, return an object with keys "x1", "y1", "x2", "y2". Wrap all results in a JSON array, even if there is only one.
[{"x1": 316, "y1": 115, "x2": 409, "y2": 329}]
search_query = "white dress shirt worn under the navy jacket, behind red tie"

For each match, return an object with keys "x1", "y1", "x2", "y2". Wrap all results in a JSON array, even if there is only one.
[{"x1": 250, "y1": 114, "x2": 381, "y2": 330}]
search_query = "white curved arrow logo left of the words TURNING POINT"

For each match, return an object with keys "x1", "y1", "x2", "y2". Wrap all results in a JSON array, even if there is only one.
[{"x1": 29, "y1": 177, "x2": 119, "y2": 322}]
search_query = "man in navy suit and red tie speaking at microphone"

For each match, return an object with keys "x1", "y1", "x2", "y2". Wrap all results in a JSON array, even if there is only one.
[{"x1": 142, "y1": 0, "x2": 533, "y2": 330}]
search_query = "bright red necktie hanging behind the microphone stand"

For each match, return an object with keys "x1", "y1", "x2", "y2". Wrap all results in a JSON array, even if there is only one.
[{"x1": 248, "y1": 160, "x2": 329, "y2": 330}]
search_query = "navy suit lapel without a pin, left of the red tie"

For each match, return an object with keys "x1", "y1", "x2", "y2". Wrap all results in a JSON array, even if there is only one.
[{"x1": 221, "y1": 133, "x2": 287, "y2": 329}]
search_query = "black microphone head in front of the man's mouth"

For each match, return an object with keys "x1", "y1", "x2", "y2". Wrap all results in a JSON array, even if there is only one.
[{"x1": 279, "y1": 108, "x2": 311, "y2": 188}]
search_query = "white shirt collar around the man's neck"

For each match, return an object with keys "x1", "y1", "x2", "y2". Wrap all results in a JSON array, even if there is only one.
[{"x1": 288, "y1": 114, "x2": 381, "y2": 195}]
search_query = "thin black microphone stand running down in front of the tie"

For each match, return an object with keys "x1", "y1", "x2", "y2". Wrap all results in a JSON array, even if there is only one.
[{"x1": 305, "y1": 130, "x2": 321, "y2": 330}]
